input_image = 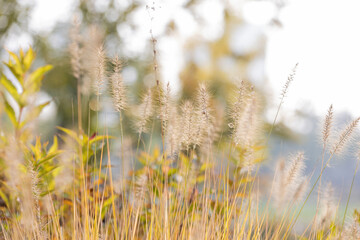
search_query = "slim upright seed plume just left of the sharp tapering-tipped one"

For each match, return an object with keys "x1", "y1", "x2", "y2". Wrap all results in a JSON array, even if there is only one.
[{"x1": 94, "y1": 46, "x2": 106, "y2": 96}]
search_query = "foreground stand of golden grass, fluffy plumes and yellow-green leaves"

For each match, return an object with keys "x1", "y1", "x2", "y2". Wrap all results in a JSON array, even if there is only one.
[{"x1": 0, "y1": 23, "x2": 360, "y2": 240}]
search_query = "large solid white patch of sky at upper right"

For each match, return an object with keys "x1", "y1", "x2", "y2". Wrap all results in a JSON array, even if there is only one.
[{"x1": 265, "y1": 0, "x2": 360, "y2": 119}]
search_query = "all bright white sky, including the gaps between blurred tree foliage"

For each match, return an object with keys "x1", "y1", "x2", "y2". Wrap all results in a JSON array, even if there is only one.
[{"x1": 8, "y1": 0, "x2": 360, "y2": 124}]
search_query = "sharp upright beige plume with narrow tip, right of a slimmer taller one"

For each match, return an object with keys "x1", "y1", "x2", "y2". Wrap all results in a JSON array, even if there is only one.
[{"x1": 110, "y1": 56, "x2": 127, "y2": 112}]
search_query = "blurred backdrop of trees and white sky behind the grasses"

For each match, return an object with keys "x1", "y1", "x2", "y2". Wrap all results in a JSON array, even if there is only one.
[{"x1": 0, "y1": 0, "x2": 360, "y2": 229}]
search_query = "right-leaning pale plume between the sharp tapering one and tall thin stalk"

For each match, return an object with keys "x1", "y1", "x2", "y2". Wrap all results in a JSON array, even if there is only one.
[{"x1": 135, "y1": 89, "x2": 153, "y2": 134}]
